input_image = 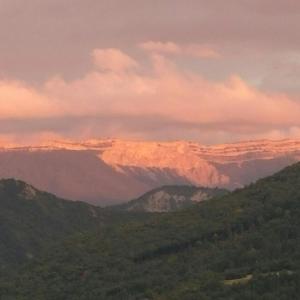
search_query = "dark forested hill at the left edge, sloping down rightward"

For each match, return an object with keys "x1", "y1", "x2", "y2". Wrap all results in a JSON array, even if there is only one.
[{"x1": 0, "y1": 179, "x2": 105, "y2": 270}]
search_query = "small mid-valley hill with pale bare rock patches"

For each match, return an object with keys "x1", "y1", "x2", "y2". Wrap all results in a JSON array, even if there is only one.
[{"x1": 116, "y1": 185, "x2": 228, "y2": 212}]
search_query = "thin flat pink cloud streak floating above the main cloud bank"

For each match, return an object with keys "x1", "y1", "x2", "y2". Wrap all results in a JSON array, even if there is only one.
[{"x1": 139, "y1": 41, "x2": 221, "y2": 59}]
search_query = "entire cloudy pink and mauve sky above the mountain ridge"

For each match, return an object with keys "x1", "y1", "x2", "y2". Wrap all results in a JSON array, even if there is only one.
[{"x1": 0, "y1": 0, "x2": 300, "y2": 144}]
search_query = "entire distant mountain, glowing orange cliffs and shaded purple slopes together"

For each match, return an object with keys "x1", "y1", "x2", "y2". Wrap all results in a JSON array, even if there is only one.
[{"x1": 0, "y1": 139, "x2": 300, "y2": 205}]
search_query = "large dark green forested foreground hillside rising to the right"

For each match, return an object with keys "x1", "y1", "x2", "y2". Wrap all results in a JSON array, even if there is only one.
[{"x1": 0, "y1": 164, "x2": 300, "y2": 300}]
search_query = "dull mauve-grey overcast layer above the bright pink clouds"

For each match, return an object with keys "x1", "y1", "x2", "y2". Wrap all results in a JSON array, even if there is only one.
[{"x1": 0, "y1": 0, "x2": 300, "y2": 91}]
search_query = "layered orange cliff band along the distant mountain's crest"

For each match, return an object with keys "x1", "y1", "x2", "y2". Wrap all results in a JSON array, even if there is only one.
[{"x1": 0, "y1": 138, "x2": 300, "y2": 164}]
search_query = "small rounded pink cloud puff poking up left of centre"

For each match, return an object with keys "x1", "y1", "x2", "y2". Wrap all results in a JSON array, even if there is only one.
[{"x1": 92, "y1": 48, "x2": 138, "y2": 72}]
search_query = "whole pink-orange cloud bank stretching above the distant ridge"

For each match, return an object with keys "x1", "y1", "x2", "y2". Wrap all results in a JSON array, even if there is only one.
[{"x1": 0, "y1": 49, "x2": 300, "y2": 143}]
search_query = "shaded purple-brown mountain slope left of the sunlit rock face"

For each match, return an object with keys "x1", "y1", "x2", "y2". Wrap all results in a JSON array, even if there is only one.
[{"x1": 0, "y1": 148, "x2": 147, "y2": 205}]
